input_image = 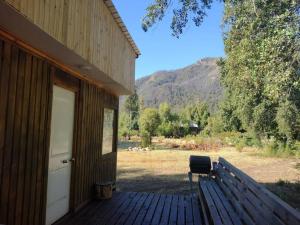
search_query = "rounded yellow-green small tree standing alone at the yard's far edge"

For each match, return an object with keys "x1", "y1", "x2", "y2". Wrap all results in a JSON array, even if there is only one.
[{"x1": 139, "y1": 108, "x2": 160, "y2": 144}]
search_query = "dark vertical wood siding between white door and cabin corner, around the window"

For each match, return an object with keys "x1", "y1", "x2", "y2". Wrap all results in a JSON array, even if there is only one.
[{"x1": 73, "y1": 81, "x2": 119, "y2": 208}]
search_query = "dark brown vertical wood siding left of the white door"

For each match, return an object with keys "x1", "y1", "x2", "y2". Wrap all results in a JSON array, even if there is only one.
[{"x1": 0, "y1": 40, "x2": 51, "y2": 225}]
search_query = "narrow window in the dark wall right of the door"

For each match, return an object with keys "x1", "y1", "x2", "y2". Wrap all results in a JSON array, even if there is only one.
[{"x1": 102, "y1": 108, "x2": 114, "y2": 155}]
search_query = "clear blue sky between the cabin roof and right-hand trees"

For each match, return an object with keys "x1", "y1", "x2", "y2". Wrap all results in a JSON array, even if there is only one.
[{"x1": 113, "y1": 0, "x2": 224, "y2": 79}]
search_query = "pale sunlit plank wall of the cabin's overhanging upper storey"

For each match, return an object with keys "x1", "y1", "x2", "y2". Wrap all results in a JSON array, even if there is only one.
[{"x1": 5, "y1": 0, "x2": 136, "y2": 91}]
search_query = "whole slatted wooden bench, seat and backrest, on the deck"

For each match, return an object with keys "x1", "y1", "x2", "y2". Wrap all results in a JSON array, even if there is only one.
[{"x1": 199, "y1": 158, "x2": 300, "y2": 225}]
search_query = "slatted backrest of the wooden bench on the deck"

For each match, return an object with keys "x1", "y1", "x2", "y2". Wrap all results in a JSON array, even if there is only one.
[{"x1": 216, "y1": 158, "x2": 300, "y2": 225}]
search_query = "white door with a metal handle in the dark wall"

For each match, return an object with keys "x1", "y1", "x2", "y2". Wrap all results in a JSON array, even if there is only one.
[{"x1": 46, "y1": 85, "x2": 75, "y2": 225}]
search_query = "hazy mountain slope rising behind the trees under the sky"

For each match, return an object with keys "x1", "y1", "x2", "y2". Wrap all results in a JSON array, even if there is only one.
[{"x1": 121, "y1": 58, "x2": 223, "y2": 111}]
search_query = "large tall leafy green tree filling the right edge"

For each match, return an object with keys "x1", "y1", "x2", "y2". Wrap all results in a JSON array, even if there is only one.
[{"x1": 219, "y1": 0, "x2": 300, "y2": 143}]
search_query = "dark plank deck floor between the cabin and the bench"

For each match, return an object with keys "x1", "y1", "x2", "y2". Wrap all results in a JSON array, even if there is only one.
[{"x1": 56, "y1": 192, "x2": 202, "y2": 225}]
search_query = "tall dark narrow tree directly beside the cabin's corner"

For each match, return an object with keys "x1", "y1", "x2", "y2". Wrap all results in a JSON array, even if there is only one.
[{"x1": 124, "y1": 89, "x2": 140, "y2": 131}]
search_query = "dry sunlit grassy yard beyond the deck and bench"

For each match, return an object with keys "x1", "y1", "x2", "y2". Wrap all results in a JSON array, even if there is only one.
[{"x1": 117, "y1": 142, "x2": 300, "y2": 209}]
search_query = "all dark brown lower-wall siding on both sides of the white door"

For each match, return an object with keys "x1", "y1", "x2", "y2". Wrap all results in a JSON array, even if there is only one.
[{"x1": 0, "y1": 39, "x2": 118, "y2": 225}]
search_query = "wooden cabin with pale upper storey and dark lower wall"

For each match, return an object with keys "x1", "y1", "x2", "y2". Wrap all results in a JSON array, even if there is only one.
[{"x1": 0, "y1": 0, "x2": 140, "y2": 225}]
